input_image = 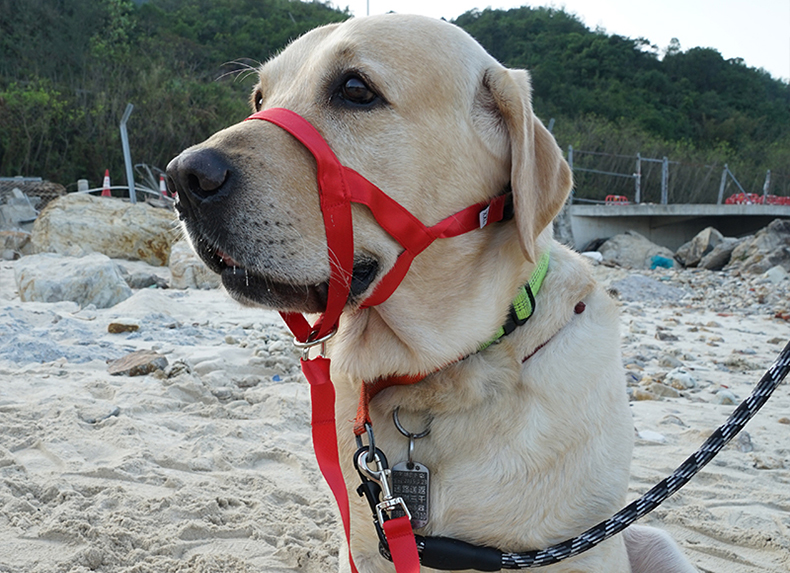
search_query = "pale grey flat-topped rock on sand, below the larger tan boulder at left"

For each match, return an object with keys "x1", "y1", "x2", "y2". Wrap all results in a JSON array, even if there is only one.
[{"x1": 14, "y1": 253, "x2": 132, "y2": 308}]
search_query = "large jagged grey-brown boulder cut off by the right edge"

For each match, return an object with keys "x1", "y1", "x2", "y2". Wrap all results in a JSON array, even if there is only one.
[{"x1": 724, "y1": 219, "x2": 790, "y2": 274}]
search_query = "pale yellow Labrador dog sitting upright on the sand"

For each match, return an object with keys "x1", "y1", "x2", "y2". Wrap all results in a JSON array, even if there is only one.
[{"x1": 168, "y1": 15, "x2": 694, "y2": 573}]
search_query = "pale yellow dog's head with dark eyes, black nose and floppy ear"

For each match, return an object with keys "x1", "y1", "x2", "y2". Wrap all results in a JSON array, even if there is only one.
[{"x1": 167, "y1": 15, "x2": 571, "y2": 312}]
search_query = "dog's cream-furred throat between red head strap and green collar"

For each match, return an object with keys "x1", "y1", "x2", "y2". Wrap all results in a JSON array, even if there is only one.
[{"x1": 324, "y1": 224, "x2": 552, "y2": 380}]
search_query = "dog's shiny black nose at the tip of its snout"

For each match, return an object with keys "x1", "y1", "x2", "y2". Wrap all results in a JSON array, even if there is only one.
[{"x1": 167, "y1": 149, "x2": 231, "y2": 203}]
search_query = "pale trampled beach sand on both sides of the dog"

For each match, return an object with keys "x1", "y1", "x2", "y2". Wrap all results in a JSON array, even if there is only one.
[{"x1": 0, "y1": 256, "x2": 790, "y2": 573}]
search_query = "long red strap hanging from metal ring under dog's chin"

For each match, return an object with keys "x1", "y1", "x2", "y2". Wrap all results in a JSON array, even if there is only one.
[{"x1": 302, "y1": 357, "x2": 358, "y2": 573}]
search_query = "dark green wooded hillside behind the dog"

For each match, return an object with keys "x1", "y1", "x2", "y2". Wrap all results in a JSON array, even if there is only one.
[{"x1": 0, "y1": 0, "x2": 790, "y2": 202}]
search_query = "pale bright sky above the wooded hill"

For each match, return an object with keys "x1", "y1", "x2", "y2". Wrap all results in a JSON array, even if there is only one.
[{"x1": 332, "y1": 0, "x2": 790, "y2": 82}]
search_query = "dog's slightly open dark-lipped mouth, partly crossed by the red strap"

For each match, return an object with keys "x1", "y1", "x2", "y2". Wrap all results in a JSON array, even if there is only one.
[{"x1": 200, "y1": 241, "x2": 379, "y2": 314}]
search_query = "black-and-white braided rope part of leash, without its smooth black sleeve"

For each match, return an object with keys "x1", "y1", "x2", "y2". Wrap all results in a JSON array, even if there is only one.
[{"x1": 501, "y1": 342, "x2": 790, "y2": 569}]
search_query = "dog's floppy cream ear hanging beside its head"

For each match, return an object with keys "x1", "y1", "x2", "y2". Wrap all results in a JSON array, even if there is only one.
[{"x1": 484, "y1": 68, "x2": 573, "y2": 262}]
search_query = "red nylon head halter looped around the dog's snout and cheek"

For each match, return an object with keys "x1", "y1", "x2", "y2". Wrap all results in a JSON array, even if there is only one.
[{"x1": 247, "y1": 108, "x2": 508, "y2": 342}]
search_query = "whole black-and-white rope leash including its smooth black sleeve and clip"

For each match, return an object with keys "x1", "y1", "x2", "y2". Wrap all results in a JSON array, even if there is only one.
[{"x1": 370, "y1": 342, "x2": 790, "y2": 571}]
